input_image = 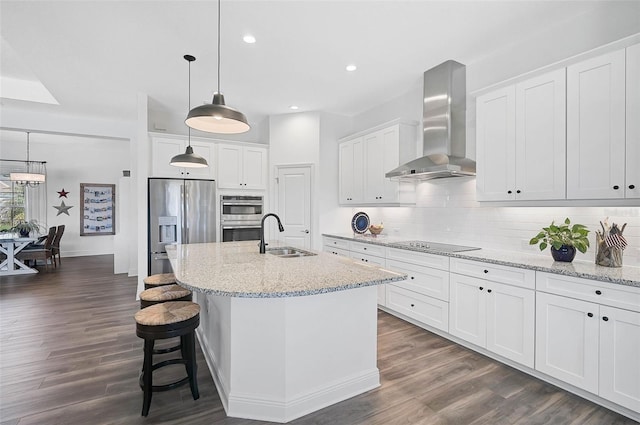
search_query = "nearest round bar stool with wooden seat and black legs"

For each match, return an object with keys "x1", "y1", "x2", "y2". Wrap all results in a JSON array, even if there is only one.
[{"x1": 134, "y1": 301, "x2": 200, "y2": 416}]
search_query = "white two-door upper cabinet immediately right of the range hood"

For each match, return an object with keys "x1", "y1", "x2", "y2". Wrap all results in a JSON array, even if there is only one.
[{"x1": 476, "y1": 69, "x2": 565, "y2": 201}]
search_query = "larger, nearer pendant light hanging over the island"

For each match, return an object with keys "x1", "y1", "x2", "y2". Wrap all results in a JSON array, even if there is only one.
[{"x1": 185, "y1": 0, "x2": 250, "y2": 134}]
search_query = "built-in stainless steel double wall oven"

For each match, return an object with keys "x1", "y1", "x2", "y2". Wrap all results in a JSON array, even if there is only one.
[{"x1": 220, "y1": 195, "x2": 264, "y2": 242}]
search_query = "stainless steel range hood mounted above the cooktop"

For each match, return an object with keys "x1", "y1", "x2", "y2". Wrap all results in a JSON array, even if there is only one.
[{"x1": 385, "y1": 60, "x2": 476, "y2": 181}]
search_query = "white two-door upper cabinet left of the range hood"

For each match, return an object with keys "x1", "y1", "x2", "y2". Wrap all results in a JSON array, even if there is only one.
[{"x1": 339, "y1": 123, "x2": 416, "y2": 205}]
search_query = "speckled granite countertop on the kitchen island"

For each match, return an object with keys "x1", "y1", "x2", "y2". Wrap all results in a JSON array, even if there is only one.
[{"x1": 167, "y1": 241, "x2": 407, "y2": 298}]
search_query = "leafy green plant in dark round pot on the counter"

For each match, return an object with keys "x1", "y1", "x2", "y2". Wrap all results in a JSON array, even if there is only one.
[{"x1": 529, "y1": 218, "x2": 589, "y2": 262}]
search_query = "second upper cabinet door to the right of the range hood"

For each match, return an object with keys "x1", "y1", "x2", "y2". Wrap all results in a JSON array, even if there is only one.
[{"x1": 515, "y1": 68, "x2": 566, "y2": 200}]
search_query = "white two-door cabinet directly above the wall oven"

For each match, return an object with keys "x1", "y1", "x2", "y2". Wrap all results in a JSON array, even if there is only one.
[{"x1": 218, "y1": 144, "x2": 267, "y2": 190}]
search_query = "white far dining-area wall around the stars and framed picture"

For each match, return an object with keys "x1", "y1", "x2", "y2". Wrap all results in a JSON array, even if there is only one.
[{"x1": 2, "y1": 131, "x2": 130, "y2": 257}]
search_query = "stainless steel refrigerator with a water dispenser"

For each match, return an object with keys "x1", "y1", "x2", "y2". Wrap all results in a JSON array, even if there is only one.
[{"x1": 147, "y1": 178, "x2": 216, "y2": 275}]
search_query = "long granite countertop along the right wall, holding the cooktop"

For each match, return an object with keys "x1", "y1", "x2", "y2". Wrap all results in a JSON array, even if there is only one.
[{"x1": 323, "y1": 234, "x2": 640, "y2": 287}]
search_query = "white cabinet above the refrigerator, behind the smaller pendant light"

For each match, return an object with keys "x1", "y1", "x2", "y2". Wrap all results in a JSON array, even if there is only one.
[{"x1": 151, "y1": 137, "x2": 215, "y2": 179}]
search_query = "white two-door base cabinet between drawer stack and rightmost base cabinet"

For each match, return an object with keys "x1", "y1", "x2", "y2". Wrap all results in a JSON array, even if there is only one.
[{"x1": 449, "y1": 259, "x2": 535, "y2": 368}]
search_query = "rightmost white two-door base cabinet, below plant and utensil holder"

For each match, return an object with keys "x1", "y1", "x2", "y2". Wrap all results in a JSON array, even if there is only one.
[{"x1": 536, "y1": 272, "x2": 640, "y2": 412}]
